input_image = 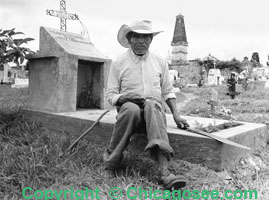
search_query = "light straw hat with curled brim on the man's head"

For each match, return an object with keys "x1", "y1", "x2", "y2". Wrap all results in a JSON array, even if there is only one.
[{"x1": 117, "y1": 20, "x2": 163, "y2": 48}]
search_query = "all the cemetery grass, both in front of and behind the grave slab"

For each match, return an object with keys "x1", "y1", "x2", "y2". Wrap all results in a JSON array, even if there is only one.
[{"x1": 0, "y1": 82, "x2": 269, "y2": 200}]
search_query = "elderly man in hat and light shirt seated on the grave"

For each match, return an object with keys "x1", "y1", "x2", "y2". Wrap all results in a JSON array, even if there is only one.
[{"x1": 104, "y1": 20, "x2": 189, "y2": 189}]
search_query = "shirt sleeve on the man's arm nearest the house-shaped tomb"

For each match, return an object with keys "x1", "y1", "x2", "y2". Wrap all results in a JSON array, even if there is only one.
[{"x1": 106, "y1": 62, "x2": 121, "y2": 106}]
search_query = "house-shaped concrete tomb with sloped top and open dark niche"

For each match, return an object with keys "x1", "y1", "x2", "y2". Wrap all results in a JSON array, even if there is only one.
[{"x1": 28, "y1": 27, "x2": 111, "y2": 113}]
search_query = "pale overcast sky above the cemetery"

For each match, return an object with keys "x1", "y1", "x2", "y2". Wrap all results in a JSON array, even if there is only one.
[{"x1": 0, "y1": 0, "x2": 269, "y2": 65}]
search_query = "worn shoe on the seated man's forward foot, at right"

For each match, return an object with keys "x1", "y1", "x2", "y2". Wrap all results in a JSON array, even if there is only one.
[{"x1": 160, "y1": 173, "x2": 187, "y2": 190}]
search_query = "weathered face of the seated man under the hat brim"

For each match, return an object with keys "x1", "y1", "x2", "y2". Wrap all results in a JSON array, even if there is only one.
[{"x1": 129, "y1": 32, "x2": 152, "y2": 56}]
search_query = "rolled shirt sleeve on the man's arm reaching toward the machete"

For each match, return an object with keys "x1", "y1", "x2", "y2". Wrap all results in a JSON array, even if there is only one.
[{"x1": 161, "y1": 60, "x2": 176, "y2": 101}]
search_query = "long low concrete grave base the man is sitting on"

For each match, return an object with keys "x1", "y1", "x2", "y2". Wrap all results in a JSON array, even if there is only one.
[{"x1": 24, "y1": 110, "x2": 268, "y2": 171}]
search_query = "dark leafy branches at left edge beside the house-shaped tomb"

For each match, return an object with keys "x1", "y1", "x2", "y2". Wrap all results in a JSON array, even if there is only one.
[{"x1": 0, "y1": 28, "x2": 34, "y2": 66}]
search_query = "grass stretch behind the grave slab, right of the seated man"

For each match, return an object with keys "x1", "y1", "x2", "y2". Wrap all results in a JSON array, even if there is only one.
[{"x1": 181, "y1": 83, "x2": 269, "y2": 123}]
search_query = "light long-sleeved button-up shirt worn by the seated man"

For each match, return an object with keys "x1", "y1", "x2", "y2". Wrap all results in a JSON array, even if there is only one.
[{"x1": 107, "y1": 49, "x2": 176, "y2": 106}]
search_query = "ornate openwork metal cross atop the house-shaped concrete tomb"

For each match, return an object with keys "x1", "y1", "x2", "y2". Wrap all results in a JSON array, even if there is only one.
[{"x1": 47, "y1": 0, "x2": 78, "y2": 32}]
